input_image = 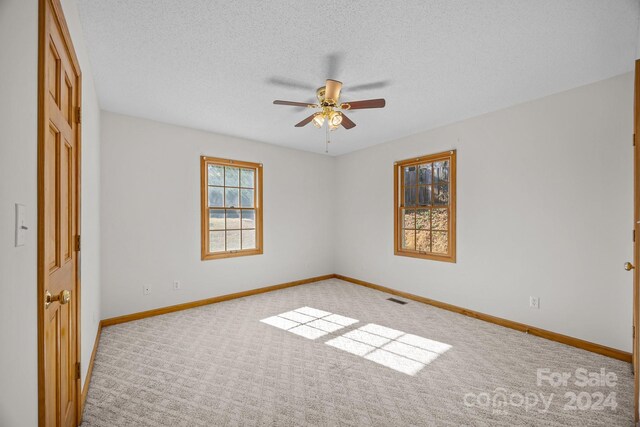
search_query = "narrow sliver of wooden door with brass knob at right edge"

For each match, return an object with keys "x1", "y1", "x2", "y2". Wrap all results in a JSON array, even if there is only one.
[{"x1": 625, "y1": 60, "x2": 640, "y2": 422}]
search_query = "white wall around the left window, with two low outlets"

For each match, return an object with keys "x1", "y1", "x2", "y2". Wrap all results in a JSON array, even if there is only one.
[{"x1": 101, "y1": 112, "x2": 334, "y2": 318}]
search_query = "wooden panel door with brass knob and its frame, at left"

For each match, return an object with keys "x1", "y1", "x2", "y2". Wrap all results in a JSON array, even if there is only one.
[{"x1": 38, "y1": 0, "x2": 81, "y2": 427}]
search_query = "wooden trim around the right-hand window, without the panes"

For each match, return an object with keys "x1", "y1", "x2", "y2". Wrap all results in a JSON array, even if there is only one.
[{"x1": 393, "y1": 150, "x2": 457, "y2": 263}]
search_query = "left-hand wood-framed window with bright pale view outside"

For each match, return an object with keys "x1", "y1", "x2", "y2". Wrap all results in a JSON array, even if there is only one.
[{"x1": 200, "y1": 156, "x2": 262, "y2": 260}]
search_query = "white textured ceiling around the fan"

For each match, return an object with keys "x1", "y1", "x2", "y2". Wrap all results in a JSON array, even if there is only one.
[{"x1": 78, "y1": 0, "x2": 639, "y2": 155}]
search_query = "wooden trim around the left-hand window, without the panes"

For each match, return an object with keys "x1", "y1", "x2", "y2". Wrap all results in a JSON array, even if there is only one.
[{"x1": 200, "y1": 156, "x2": 263, "y2": 261}]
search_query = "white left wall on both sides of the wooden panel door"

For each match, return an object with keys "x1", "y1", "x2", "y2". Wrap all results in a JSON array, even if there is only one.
[{"x1": 0, "y1": 0, "x2": 100, "y2": 427}]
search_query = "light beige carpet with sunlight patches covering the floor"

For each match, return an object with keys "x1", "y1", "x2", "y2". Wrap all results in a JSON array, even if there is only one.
[{"x1": 83, "y1": 280, "x2": 633, "y2": 426}]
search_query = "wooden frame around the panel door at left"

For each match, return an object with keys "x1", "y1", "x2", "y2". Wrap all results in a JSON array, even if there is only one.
[{"x1": 36, "y1": 0, "x2": 82, "y2": 426}]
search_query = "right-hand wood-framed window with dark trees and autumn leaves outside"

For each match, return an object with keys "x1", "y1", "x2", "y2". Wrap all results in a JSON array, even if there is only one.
[{"x1": 394, "y1": 151, "x2": 456, "y2": 262}]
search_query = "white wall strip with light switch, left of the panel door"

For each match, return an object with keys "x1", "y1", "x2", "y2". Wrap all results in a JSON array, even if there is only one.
[{"x1": 0, "y1": 0, "x2": 38, "y2": 426}]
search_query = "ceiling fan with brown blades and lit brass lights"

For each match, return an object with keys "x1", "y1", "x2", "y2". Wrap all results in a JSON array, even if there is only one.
[{"x1": 273, "y1": 79, "x2": 386, "y2": 130}]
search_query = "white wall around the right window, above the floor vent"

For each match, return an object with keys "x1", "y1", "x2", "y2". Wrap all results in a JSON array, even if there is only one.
[{"x1": 334, "y1": 73, "x2": 633, "y2": 351}]
